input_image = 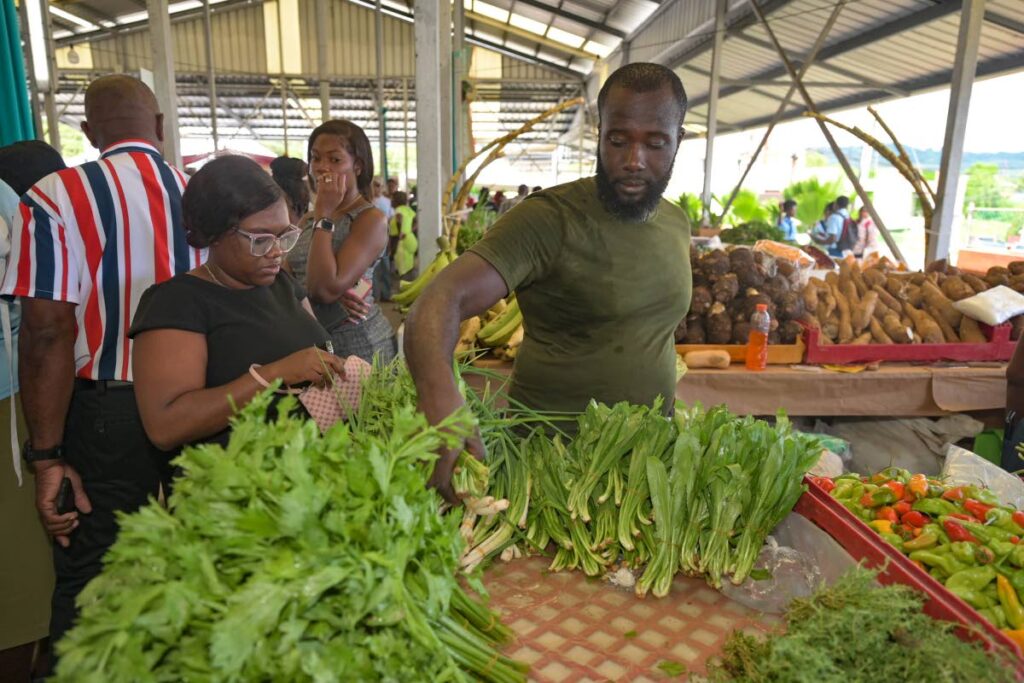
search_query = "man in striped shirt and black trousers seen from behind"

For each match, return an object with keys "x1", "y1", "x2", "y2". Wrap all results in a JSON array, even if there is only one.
[{"x1": 0, "y1": 76, "x2": 201, "y2": 643}]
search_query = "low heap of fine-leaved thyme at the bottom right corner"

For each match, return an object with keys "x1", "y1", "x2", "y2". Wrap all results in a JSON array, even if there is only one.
[{"x1": 709, "y1": 569, "x2": 1017, "y2": 683}]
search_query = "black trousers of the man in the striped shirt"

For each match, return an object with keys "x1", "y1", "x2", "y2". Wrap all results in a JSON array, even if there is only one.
[{"x1": 50, "y1": 381, "x2": 170, "y2": 643}]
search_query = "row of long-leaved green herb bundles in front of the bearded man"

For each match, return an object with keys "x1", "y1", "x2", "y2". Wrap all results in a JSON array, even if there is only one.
[{"x1": 462, "y1": 403, "x2": 820, "y2": 597}]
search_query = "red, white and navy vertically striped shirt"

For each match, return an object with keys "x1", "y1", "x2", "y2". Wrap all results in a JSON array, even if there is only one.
[{"x1": 0, "y1": 140, "x2": 205, "y2": 381}]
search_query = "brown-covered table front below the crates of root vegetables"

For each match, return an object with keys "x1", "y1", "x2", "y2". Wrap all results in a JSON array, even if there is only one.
[{"x1": 468, "y1": 359, "x2": 1007, "y2": 418}]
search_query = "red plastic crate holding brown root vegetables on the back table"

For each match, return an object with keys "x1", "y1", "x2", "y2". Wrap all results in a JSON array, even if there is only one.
[{"x1": 804, "y1": 323, "x2": 1017, "y2": 366}]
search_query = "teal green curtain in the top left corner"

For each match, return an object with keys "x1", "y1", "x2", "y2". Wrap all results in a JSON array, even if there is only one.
[{"x1": 0, "y1": 0, "x2": 36, "y2": 146}]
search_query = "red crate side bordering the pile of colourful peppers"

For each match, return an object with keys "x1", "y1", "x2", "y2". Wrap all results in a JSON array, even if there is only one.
[{"x1": 795, "y1": 477, "x2": 1024, "y2": 677}]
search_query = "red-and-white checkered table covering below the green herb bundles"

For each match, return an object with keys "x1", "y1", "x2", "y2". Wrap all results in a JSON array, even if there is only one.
[{"x1": 484, "y1": 557, "x2": 778, "y2": 683}]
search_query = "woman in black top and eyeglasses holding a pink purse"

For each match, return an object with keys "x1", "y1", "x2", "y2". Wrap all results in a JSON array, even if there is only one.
[{"x1": 129, "y1": 157, "x2": 343, "y2": 450}]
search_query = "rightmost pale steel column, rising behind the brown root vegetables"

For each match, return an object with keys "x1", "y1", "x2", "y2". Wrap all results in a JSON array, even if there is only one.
[{"x1": 925, "y1": 0, "x2": 985, "y2": 262}]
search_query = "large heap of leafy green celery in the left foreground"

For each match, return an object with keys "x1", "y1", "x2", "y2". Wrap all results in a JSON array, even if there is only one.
[{"x1": 57, "y1": 389, "x2": 525, "y2": 683}]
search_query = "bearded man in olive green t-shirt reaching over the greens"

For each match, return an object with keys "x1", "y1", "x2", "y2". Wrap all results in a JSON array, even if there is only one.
[{"x1": 404, "y1": 62, "x2": 692, "y2": 502}]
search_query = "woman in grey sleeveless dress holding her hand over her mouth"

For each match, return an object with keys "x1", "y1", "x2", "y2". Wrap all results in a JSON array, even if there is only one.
[{"x1": 288, "y1": 121, "x2": 397, "y2": 362}]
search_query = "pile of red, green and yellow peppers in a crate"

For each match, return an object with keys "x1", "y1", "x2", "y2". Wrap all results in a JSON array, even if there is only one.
[{"x1": 813, "y1": 467, "x2": 1024, "y2": 648}]
